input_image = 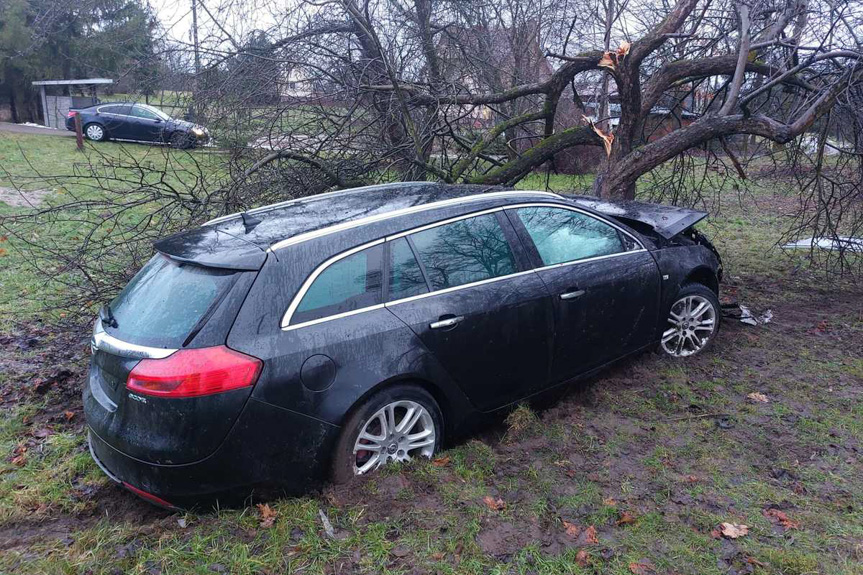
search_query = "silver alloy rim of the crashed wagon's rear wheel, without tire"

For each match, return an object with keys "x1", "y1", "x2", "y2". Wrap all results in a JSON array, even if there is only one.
[{"x1": 353, "y1": 400, "x2": 436, "y2": 475}]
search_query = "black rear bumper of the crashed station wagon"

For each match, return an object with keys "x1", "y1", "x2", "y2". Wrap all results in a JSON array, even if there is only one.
[{"x1": 88, "y1": 400, "x2": 339, "y2": 507}]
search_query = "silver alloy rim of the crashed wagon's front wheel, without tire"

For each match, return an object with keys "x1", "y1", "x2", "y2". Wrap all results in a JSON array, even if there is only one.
[{"x1": 662, "y1": 295, "x2": 716, "y2": 357}]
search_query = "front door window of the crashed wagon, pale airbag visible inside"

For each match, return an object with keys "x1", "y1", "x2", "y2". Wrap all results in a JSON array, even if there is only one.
[{"x1": 515, "y1": 207, "x2": 626, "y2": 266}]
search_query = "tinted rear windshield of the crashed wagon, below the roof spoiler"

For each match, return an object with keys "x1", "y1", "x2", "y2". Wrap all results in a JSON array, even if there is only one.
[{"x1": 102, "y1": 255, "x2": 237, "y2": 348}]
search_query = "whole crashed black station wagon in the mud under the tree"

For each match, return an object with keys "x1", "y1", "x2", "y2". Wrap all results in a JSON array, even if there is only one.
[{"x1": 84, "y1": 183, "x2": 721, "y2": 506}]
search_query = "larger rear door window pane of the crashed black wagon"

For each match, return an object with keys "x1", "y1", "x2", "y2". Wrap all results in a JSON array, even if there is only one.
[{"x1": 411, "y1": 214, "x2": 516, "y2": 290}]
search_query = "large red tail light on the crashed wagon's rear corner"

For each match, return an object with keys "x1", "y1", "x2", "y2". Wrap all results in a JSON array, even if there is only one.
[{"x1": 126, "y1": 345, "x2": 263, "y2": 397}]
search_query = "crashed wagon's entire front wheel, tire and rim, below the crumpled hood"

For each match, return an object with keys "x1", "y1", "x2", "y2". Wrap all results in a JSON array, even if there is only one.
[{"x1": 659, "y1": 283, "x2": 721, "y2": 358}]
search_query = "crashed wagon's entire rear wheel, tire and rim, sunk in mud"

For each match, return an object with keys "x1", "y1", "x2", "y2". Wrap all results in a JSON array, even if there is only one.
[{"x1": 332, "y1": 384, "x2": 443, "y2": 483}]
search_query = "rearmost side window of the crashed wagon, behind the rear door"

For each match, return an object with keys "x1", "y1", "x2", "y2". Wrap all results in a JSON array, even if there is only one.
[{"x1": 291, "y1": 244, "x2": 383, "y2": 325}]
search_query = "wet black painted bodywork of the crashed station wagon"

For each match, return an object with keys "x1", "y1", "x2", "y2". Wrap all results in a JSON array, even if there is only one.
[{"x1": 84, "y1": 184, "x2": 720, "y2": 505}]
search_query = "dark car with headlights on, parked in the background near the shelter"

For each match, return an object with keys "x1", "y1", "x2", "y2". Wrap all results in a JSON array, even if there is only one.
[{"x1": 66, "y1": 102, "x2": 210, "y2": 148}]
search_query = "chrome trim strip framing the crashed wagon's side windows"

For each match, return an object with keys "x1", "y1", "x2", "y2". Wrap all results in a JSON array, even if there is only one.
[{"x1": 271, "y1": 198, "x2": 647, "y2": 331}]
